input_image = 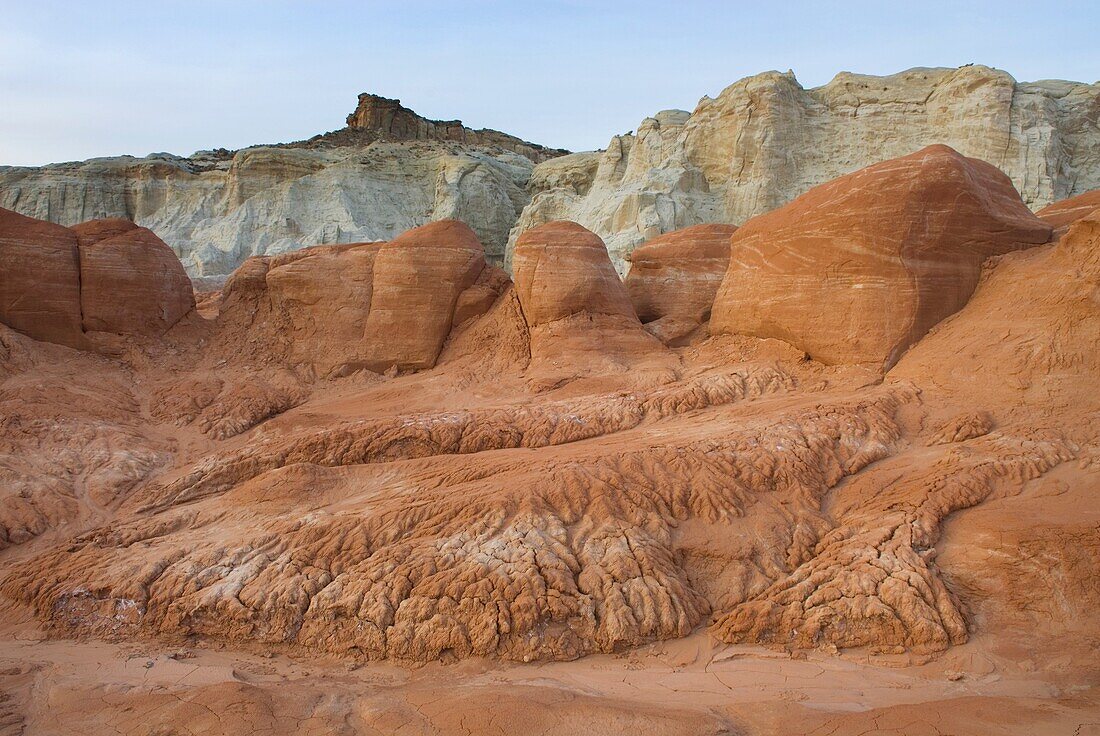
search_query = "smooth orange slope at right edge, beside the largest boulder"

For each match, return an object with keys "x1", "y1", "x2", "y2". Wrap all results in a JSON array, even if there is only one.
[{"x1": 890, "y1": 210, "x2": 1100, "y2": 422}]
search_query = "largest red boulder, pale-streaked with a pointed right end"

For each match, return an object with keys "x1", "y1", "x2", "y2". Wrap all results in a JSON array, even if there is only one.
[{"x1": 711, "y1": 145, "x2": 1051, "y2": 367}]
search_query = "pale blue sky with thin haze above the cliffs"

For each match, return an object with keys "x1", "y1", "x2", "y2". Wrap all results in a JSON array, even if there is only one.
[{"x1": 0, "y1": 0, "x2": 1100, "y2": 165}]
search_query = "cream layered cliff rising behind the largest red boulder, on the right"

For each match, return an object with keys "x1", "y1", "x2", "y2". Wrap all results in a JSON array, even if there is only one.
[{"x1": 510, "y1": 66, "x2": 1100, "y2": 273}]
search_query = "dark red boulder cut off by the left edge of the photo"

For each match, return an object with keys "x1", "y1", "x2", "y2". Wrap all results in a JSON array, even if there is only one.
[{"x1": 0, "y1": 209, "x2": 85, "y2": 348}]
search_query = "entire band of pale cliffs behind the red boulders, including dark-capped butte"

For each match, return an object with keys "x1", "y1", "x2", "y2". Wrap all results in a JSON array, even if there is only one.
[{"x1": 8, "y1": 66, "x2": 1100, "y2": 278}]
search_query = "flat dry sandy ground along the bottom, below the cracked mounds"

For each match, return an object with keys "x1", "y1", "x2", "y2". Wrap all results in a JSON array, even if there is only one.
[{"x1": 0, "y1": 539, "x2": 1100, "y2": 736}]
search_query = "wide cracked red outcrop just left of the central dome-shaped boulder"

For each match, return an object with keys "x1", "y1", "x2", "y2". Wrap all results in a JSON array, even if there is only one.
[{"x1": 198, "y1": 220, "x2": 510, "y2": 377}]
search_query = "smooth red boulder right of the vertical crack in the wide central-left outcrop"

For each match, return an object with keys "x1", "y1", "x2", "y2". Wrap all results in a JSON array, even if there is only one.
[{"x1": 363, "y1": 220, "x2": 485, "y2": 371}]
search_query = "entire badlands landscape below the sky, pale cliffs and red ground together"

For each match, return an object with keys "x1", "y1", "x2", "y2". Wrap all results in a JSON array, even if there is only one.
[{"x1": 0, "y1": 67, "x2": 1100, "y2": 736}]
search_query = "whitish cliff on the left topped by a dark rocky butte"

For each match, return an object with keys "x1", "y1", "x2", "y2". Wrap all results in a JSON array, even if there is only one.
[{"x1": 0, "y1": 95, "x2": 565, "y2": 276}]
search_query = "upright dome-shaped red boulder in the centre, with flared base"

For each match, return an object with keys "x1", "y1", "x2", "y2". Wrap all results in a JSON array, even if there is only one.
[{"x1": 513, "y1": 221, "x2": 663, "y2": 385}]
